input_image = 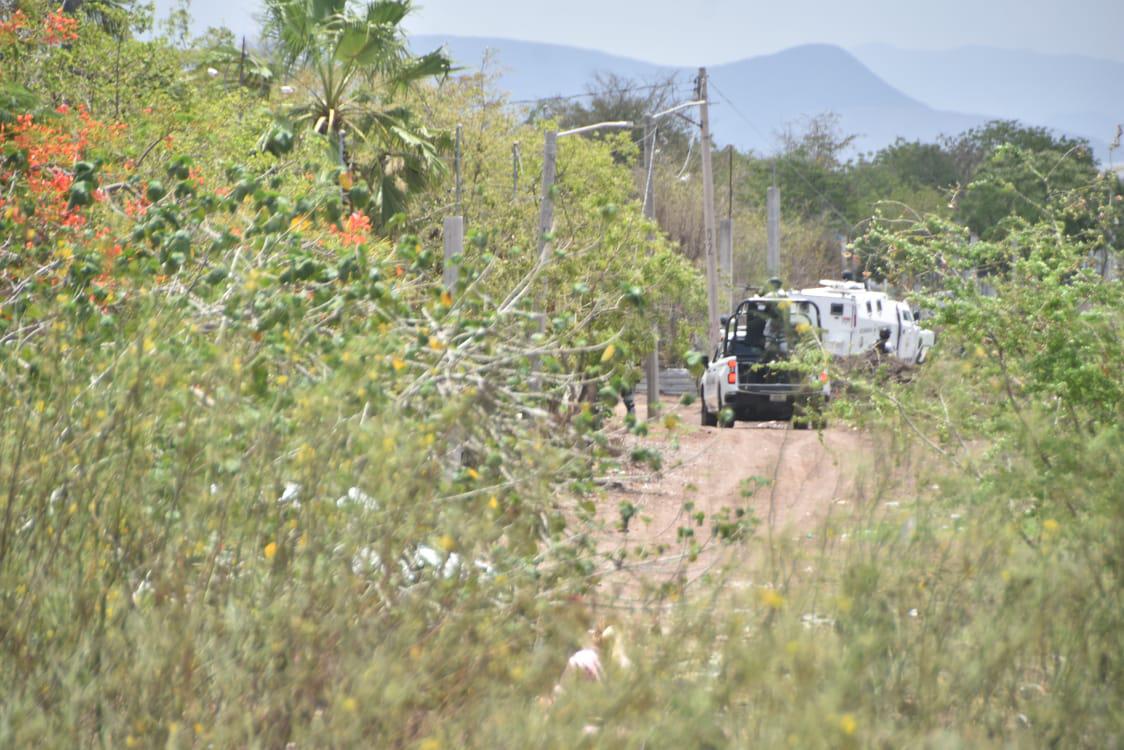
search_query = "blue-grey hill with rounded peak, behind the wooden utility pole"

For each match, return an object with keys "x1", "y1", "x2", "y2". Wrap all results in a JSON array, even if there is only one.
[{"x1": 411, "y1": 36, "x2": 988, "y2": 154}]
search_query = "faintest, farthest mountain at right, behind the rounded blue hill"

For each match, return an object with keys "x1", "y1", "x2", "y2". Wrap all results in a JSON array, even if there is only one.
[{"x1": 854, "y1": 44, "x2": 1124, "y2": 156}]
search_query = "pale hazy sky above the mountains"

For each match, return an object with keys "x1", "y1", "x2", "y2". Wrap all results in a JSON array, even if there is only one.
[{"x1": 170, "y1": 0, "x2": 1124, "y2": 66}]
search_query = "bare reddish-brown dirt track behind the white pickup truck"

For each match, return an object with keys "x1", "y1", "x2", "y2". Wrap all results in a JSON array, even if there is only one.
[{"x1": 602, "y1": 399, "x2": 872, "y2": 581}]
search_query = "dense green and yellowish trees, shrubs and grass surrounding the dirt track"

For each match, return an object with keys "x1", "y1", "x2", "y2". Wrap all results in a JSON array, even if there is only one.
[{"x1": 0, "y1": 0, "x2": 1124, "y2": 750}]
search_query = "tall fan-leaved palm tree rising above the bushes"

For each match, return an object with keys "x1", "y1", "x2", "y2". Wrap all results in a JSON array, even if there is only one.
[{"x1": 265, "y1": 0, "x2": 450, "y2": 229}]
